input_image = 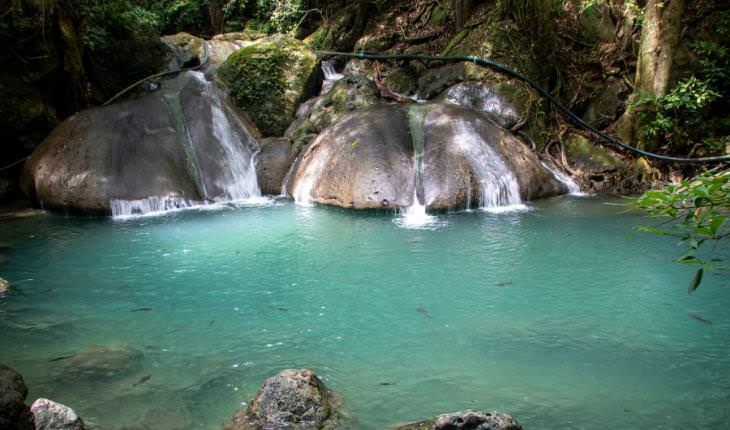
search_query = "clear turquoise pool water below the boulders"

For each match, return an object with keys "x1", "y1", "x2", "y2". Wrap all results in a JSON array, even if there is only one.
[{"x1": 0, "y1": 197, "x2": 730, "y2": 430}]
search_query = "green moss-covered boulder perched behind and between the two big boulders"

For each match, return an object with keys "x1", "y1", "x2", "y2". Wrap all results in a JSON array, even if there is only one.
[{"x1": 218, "y1": 35, "x2": 321, "y2": 136}]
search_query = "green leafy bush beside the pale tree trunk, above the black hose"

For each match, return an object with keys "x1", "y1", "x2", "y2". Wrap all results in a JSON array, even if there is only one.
[{"x1": 632, "y1": 42, "x2": 730, "y2": 154}]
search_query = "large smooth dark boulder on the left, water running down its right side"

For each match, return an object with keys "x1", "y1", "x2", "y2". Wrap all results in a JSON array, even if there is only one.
[{"x1": 21, "y1": 72, "x2": 258, "y2": 214}]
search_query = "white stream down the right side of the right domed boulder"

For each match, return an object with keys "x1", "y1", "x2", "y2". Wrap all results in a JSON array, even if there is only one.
[{"x1": 453, "y1": 119, "x2": 527, "y2": 212}]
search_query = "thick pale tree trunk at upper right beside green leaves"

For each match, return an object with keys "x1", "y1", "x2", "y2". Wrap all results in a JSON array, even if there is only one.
[{"x1": 615, "y1": 0, "x2": 684, "y2": 150}]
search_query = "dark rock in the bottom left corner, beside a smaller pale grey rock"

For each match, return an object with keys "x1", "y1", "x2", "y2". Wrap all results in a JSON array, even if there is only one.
[{"x1": 0, "y1": 363, "x2": 33, "y2": 430}]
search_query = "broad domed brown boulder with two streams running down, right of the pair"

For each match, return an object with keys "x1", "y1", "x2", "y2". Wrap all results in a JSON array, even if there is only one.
[{"x1": 289, "y1": 104, "x2": 566, "y2": 210}]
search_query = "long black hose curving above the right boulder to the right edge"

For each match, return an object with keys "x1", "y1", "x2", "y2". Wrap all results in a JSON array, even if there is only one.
[{"x1": 316, "y1": 51, "x2": 730, "y2": 163}]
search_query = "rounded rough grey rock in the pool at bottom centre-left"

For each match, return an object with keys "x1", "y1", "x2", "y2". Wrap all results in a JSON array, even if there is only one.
[{"x1": 224, "y1": 369, "x2": 341, "y2": 430}]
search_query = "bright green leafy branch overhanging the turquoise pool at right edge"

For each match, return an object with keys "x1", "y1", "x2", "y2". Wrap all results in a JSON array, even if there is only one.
[{"x1": 634, "y1": 168, "x2": 730, "y2": 293}]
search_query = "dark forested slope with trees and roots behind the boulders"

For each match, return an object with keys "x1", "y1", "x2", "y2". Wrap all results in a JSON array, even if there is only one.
[{"x1": 0, "y1": 0, "x2": 730, "y2": 202}]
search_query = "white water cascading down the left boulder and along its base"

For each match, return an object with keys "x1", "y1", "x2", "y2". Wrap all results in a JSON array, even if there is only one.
[{"x1": 110, "y1": 72, "x2": 262, "y2": 218}]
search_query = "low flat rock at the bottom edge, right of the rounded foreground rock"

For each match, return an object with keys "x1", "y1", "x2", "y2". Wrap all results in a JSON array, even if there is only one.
[{"x1": 394, "y1": 409, "x2": 522, "y2": 430}]
